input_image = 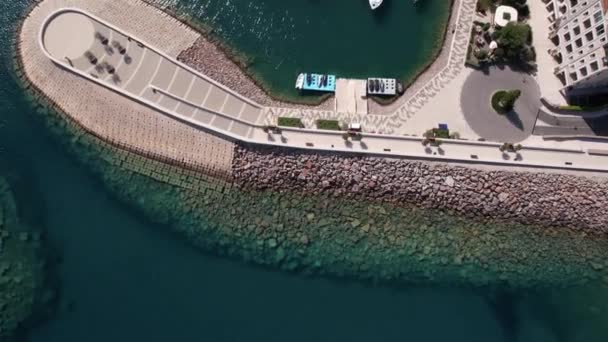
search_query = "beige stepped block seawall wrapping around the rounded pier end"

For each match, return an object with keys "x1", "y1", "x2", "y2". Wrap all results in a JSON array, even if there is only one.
[{"x1": 18, "y1": 0, "x2": 234, "y2": 177}]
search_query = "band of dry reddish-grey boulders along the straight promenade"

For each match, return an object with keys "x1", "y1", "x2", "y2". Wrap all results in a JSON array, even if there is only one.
[{"x1": 233, "y1": 146, "x2": 608, "y2": 234}]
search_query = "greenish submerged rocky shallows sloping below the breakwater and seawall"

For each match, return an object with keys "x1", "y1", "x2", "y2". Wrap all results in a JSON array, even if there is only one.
[{"x1": 11, "y1": 73, "x2": 608, "y2": 341}]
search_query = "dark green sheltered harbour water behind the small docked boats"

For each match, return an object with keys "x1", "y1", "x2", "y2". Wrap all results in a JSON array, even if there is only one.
[{"x1": 159, "y1": 0, "x2": 449, "y2": 94}]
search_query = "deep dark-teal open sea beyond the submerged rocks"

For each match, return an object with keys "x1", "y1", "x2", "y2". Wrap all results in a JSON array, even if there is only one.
[{"x1": 0, "y1": 1, "x2": 608, "y2": 342}]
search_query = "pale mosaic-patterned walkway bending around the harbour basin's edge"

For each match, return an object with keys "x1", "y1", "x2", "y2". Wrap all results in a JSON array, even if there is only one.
[{"x1": 265, "y1": 0, "x2": 477, "y2": 134}]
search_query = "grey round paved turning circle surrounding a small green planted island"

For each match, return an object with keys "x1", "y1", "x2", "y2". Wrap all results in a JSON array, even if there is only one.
[{"x1": 460, "y1": 67, "x2": 540, "y2": 143}]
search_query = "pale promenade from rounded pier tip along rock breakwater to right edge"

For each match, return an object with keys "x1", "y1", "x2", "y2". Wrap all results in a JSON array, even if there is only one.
[{"x1": 27, "y1": 3, "x2": 608, "y2": 171}]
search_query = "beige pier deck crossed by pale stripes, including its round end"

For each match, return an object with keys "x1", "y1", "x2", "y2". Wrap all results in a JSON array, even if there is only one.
[{"x1": 41, "y1": 9, "x2": 262, "y2": 138}]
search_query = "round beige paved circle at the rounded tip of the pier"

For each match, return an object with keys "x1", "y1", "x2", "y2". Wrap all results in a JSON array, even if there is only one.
[{"x1": 43, "y1": 11, "x2": 95, "y2": 60}]
